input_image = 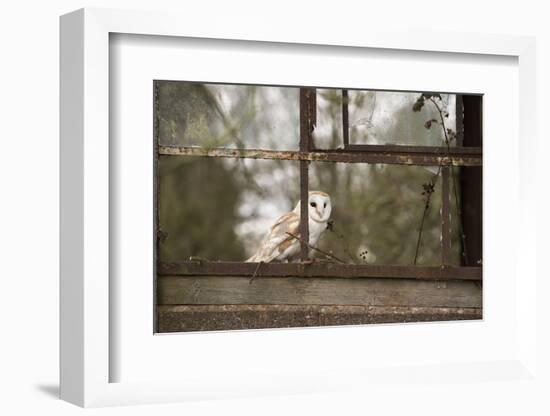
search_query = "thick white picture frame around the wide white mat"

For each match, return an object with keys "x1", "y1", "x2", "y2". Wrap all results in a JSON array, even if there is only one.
[{"x1": 60, "y1": 9, "x2": 541, "y2": 407}]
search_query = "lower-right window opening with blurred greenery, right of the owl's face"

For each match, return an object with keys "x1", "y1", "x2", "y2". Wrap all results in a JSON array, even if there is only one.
[{"x1": 309, "y1": 163, "x2": 460, "y2": 266}]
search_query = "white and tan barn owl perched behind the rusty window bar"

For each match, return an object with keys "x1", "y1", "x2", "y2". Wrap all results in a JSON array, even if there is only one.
[{"x1": 247, "y1": 191, "x2": 332, "y2": 263}]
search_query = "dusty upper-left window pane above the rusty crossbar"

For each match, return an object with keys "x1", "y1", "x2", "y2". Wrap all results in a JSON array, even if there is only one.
[{"x1": 157, "y1": 81, "x2": 300, "y2": 150}]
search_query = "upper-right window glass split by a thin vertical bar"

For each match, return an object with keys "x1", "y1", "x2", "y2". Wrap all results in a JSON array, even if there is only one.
[{"x1": 313, "y1": 89, "x2": 456, "y2": 149}]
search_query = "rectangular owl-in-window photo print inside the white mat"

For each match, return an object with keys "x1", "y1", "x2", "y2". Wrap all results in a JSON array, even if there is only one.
[{"x1": 153, "y1": 80, "x2": 483, "y2": 333}]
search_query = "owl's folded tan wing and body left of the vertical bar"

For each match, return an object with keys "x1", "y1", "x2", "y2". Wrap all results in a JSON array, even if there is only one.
[{"x1": 247, "y1": 212, "x2": 300, "y2": 263}]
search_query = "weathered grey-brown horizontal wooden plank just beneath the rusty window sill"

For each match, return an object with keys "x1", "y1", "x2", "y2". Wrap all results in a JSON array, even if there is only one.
[{"x1": 157, "y1": 276, "x2": 481, "y2": 308}]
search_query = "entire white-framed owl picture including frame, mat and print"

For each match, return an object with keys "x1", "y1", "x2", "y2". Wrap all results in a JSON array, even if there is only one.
[{"x1": 61, "y1": 9, "x2": 537, "y2": 406}]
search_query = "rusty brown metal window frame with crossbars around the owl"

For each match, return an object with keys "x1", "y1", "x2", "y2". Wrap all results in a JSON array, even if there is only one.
[{"x1": 155, "y1": 83, "x2": 482, "y2": 281}]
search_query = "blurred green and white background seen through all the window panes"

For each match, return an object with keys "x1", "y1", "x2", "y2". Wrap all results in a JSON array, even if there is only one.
[{"x1": 155, "y1": 81, "x2": 460, "y2": 265}]
